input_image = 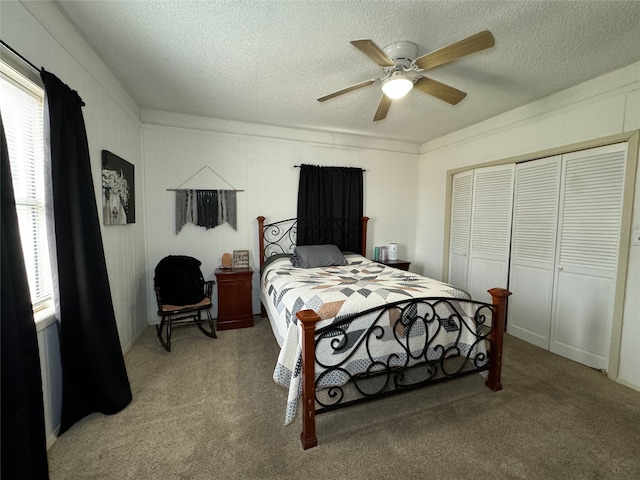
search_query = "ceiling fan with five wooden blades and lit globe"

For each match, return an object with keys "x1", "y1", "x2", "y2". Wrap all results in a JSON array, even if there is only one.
[{"x1": 318, "y1": 30, "x2": 495, "y2": 122}]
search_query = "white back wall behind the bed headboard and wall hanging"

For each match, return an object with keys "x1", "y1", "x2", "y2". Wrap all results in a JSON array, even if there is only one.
[{"x1": 143, "y1": 111, "x2": 418, "y2": 316}]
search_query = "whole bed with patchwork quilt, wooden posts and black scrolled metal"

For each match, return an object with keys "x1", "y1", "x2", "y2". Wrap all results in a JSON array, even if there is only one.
[{"x1": 257, "y1": 216, "x2": 510, "y2": 449}]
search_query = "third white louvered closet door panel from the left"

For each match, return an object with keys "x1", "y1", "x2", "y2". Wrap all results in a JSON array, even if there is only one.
[{"x1": 507, "y1": 156, "x2": 561, "y2": 350}]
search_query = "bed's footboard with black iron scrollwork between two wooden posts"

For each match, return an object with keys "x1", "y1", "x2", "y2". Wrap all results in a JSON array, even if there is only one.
[{"x1": 298, "y1": 289, "x2": 511, "y2": 448}]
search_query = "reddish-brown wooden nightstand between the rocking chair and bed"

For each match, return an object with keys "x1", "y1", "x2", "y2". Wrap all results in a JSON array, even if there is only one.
[{"x1": 216, "y1": 268, "x2": 253, "y2": 330}]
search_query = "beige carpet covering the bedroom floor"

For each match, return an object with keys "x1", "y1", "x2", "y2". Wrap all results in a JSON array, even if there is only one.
[{"x1": 49, "y1": 317, "x2": 640, "y2": 480}]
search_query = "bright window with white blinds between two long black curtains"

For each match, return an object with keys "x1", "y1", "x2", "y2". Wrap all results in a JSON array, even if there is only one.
[{"x1": 0, "y1": 62, "x2": 52, "y2": 319}]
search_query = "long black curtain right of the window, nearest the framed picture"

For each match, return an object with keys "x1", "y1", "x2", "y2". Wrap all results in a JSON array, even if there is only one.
[{"x1": 41, "y1": 70, "x2": 131, "y2": 433}]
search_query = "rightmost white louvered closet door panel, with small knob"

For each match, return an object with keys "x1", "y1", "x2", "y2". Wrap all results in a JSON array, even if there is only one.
[{"x1": 549, "y1": 144, "x2": 626, "y2": 369}]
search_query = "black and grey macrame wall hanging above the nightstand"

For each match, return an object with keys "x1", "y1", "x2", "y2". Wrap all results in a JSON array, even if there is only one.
[{"x1": 167, "y1": 165, "x2": 244, "y2": 235}]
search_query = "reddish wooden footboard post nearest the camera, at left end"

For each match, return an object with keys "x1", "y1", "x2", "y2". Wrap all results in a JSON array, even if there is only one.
[{"x1": 296, "y1": 310, "x2": 320, "y2": 450}]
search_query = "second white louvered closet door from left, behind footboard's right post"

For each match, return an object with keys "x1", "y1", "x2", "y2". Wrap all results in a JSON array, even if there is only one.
[{"x1": 468, "y1": 164, "x2": 515, "y2": 301}]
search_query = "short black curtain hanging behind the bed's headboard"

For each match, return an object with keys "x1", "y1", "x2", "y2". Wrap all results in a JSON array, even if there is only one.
[{"x1": 296, "y1": 165, "x2": 363, "y2": 253}]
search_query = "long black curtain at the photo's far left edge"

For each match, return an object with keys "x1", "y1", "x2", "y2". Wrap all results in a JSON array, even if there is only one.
[{"x1": 0, "y1": 117, "x2": 49, "y2": 479}]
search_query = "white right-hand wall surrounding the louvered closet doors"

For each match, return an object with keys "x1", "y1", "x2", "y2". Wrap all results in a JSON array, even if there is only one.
[{"x1": 415, "y1": 63, "x2": 640, "y2": 389}]
